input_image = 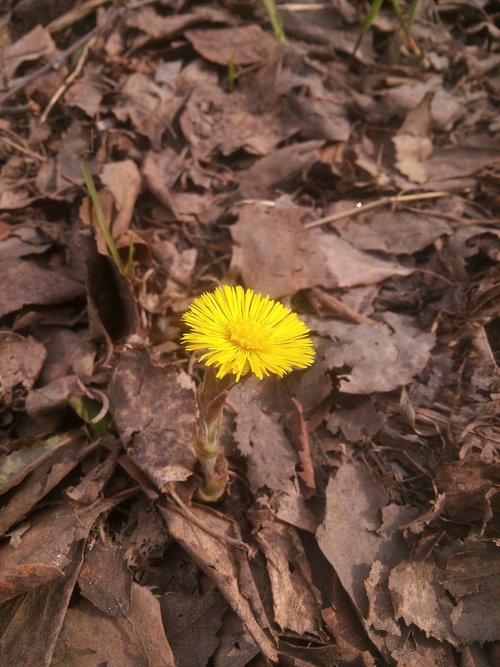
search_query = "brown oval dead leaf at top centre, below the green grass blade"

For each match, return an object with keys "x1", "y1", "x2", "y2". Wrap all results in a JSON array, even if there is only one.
[{"x1": 184, "y1": 24, "x2": 277, "y2": 67}]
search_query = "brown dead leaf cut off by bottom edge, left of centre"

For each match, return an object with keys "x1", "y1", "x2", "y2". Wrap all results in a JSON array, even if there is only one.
[{"x1": 53, "y1": 583, "x2": 175, "y2": 667}]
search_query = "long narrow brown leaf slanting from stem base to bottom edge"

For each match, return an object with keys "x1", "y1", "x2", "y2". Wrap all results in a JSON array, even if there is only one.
[{"x1": 160, "y1": 505, "x2": 278, "y2": 662}]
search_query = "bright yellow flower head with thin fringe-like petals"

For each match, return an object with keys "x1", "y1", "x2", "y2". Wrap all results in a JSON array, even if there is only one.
[{"x1": 182, "y1": 285, "x2": 314, "y2": 381}]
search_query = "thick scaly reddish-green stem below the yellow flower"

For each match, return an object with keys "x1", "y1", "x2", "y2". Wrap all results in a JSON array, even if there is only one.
[{"x1": 194, "y1": 366, "x2": 234, "y2": 503}]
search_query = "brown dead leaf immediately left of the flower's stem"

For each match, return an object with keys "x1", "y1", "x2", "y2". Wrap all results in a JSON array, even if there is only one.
[{"x1": 108, "y1": 349, "x2": 196, "y2": 489}]
